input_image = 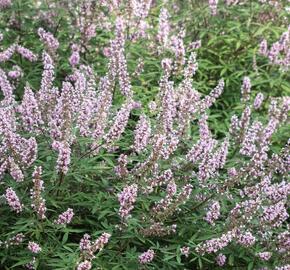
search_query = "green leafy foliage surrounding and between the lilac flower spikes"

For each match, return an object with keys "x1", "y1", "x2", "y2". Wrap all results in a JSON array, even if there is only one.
[{"x1": 0, "y1": 0, "x2": 290, "y2": 270}]
